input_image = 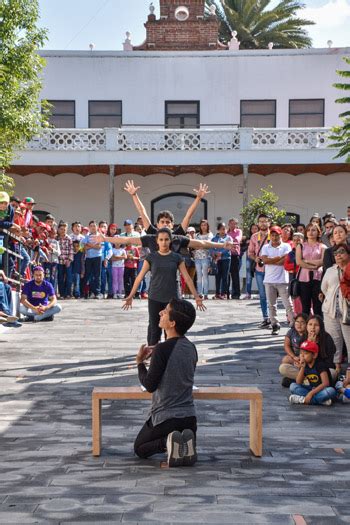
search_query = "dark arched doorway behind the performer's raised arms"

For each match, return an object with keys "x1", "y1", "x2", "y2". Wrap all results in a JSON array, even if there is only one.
[{"x1": 151, "y1": 193, "x2": 207, "y2": 226}]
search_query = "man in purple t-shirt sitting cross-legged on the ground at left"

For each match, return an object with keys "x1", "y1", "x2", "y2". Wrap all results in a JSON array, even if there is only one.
[{"x1": 20, "y1": 266, "x2": 62, "y2": 322}]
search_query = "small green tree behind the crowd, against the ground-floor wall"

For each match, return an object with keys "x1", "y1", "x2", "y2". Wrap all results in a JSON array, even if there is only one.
[{"x1": 241, "y1": 186, "x2": 286, "y2": 235}]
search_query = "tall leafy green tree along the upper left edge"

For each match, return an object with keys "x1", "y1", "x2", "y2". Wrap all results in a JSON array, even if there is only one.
[{"x1": 0, "y1": 0, "x2": 46, "y2": 190}]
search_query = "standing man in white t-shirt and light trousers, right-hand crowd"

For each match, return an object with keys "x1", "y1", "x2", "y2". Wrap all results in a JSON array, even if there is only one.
[{"x1": 261, "y1": 226, "x2": 293, "y2": 335}]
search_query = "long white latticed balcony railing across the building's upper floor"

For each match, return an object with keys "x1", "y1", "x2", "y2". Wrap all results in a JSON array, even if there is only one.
[{"x1": 27, "y1": 127, "x2": 332, "y2": 152}]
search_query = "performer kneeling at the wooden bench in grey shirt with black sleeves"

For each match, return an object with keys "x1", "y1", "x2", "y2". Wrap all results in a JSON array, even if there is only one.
[{"x1": 134, "y1": 299, "x2": 198, "y2": 467}]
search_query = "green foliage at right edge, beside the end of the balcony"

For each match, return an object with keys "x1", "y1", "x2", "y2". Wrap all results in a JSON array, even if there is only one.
[{"x1": 331, "y1": 57, "x2": 350, "y2": 162}]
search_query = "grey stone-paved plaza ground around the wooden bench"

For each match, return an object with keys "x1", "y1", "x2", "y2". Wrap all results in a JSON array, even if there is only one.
[{"x1": 0, "y1": 301, "x2": 350, "y2": 525}]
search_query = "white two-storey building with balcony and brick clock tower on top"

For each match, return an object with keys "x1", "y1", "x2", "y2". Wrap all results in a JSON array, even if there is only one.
[{"x1": 10, "y1": 0, "x2": 350, "y2": 225}]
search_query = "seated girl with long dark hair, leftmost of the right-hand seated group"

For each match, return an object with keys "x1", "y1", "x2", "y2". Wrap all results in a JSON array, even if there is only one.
[{"x1": 279, "y1": 314, "x2": 307, "y2": 388}]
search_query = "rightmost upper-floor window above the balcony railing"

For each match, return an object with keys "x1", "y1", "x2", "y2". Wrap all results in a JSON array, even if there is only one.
[{"x1": 289, "y1": 99, "x2": 324, "y2": 128}]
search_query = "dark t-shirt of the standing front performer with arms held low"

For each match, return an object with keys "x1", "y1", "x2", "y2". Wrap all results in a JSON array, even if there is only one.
[{"x1": 146, "y1": 252, "x2": 183, "y2": 303}]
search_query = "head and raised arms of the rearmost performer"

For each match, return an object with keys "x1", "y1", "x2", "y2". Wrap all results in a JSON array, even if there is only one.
[{"x1": 124, "y1": 180, "x2": 210, "y2": 235}]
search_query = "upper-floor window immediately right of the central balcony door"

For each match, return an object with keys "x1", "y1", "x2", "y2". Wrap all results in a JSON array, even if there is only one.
[{"x1": 241, "y1": 100, "x2": 276, "y2": 128}]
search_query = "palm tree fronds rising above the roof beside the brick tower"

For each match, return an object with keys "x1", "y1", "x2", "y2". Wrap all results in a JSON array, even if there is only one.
[{"x1": 206, "y1": 0, "x2": 314, "y2": 49}]
